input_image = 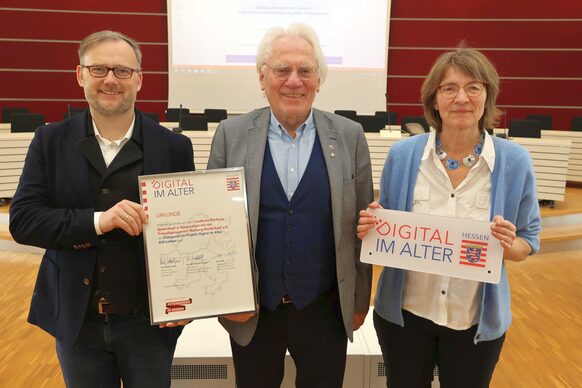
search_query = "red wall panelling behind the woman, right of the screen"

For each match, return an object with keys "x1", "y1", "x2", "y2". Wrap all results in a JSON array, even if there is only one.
[{"x1": 387, "y1": 0, "x2": 582, "y2": 133}]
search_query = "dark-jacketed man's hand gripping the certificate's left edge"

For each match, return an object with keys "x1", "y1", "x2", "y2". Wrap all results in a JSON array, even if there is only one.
[{"x1": 99, "y1": 199, "x2": 148, "y2": 236}]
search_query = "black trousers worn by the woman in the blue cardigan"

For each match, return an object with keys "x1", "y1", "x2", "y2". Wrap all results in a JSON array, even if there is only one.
[{"x1": 374, "y1": 310, "x2": 505, "y2": 388}]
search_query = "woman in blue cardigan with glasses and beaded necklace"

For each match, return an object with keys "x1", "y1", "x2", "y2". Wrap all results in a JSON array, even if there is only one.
[{"x1": 357, "y1": 48, "x2": 540, "y2": 388}]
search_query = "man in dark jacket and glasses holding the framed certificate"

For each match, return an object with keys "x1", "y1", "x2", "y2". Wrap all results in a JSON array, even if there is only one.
[{"x1": 10, "y1": 31, "x2": 194, "y2": 388}]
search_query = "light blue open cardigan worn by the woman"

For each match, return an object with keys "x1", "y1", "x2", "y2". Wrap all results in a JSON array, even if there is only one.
[{"x1": 374, "y1": 134, "x2": 541, "y2": 343}]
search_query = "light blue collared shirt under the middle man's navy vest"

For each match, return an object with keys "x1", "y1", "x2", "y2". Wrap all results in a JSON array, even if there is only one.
[{"x1": 267, "y1": 111, "x2": 315, "y2": 200}]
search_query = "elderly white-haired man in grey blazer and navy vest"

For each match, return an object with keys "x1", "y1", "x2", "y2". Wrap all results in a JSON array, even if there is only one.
[{"x1": 208, "y1": 24, "x2": 373, "y2": 388}]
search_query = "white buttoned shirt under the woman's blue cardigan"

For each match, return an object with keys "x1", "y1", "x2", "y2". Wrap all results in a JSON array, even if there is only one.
[{"x1": 403, "y1": 131, "x2": 495, "y2": 330}]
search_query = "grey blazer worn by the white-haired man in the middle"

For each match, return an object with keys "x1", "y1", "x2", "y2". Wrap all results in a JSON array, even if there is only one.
[{"x1": 208, "y1": 107, "x2": 374, "y2": 346}]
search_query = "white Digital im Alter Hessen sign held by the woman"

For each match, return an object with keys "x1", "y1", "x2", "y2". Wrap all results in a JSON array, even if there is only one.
[{"x1": 360, "y1": 209, "x2": 503, "y2": 283}]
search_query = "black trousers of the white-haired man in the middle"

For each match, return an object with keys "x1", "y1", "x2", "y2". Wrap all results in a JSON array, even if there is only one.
[{"x1": 230, "y1": 291, "x2": 347, "y2": 388}]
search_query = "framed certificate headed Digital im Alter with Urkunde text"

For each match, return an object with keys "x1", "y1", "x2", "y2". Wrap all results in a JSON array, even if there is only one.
[{"x1": 139, "y1": 167, "x2": 257, "y2": 325}]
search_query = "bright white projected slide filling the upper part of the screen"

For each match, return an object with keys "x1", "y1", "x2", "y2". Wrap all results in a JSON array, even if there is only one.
[{"x1": 172, "y1": 0, "x2": 386, "y2": 69}]
